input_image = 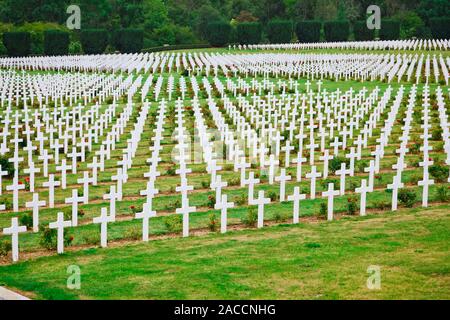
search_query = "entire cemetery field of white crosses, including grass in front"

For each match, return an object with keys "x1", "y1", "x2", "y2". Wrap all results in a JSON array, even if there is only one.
[{"x1": 0, "y1": 41, "x2": 450, "y2": 299}]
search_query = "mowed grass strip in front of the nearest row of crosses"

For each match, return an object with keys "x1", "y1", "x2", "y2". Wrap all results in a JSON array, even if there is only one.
[{"x1": 0, "y1": 206, "x2": 450, "y2": 299}]
